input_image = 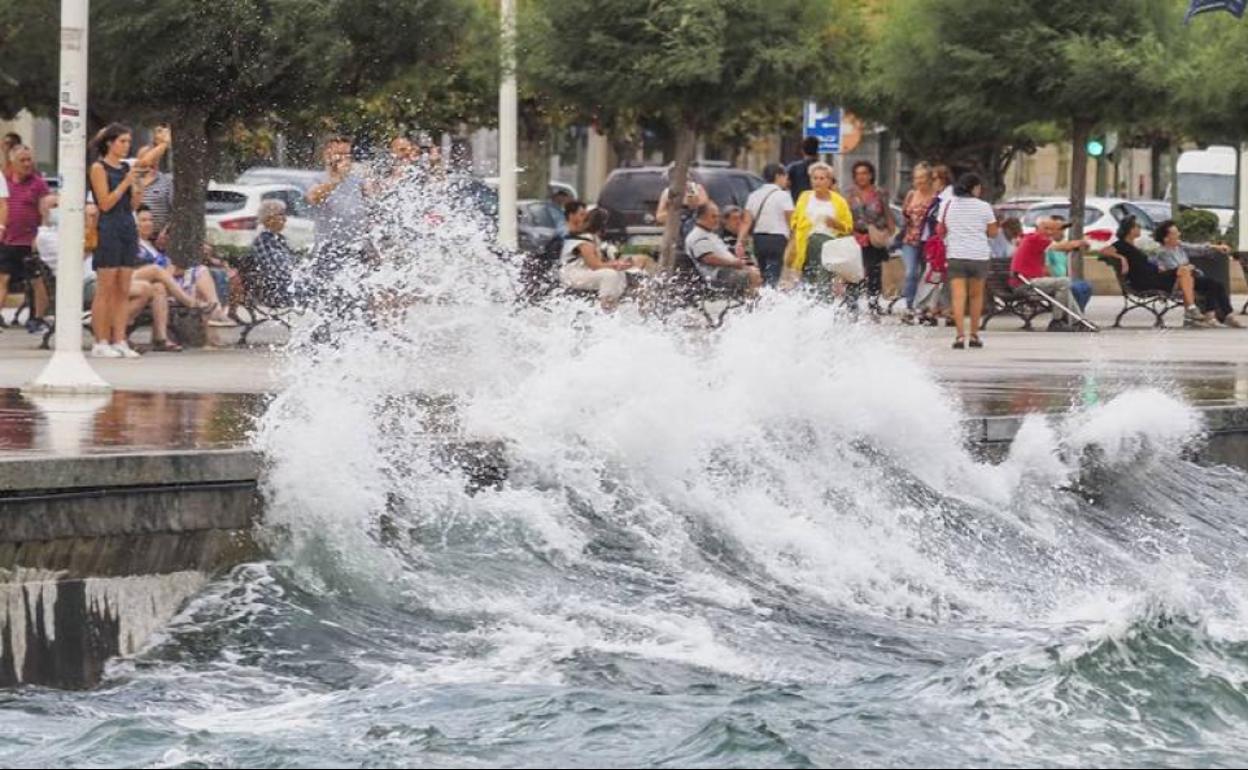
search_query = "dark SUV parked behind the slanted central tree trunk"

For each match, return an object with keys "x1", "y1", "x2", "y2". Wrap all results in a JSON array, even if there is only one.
[{"x1": 598, "y1": 161, "x2": 763, "y2": 246}]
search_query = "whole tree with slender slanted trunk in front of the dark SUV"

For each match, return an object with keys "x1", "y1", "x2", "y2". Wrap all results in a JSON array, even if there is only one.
[{"x1": 518, "y1": 0, "x2": 856, "y2": 271}]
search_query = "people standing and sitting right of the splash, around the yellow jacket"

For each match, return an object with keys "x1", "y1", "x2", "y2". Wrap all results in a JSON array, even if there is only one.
[{"x1": 559, "y1": 137, "x2": 1241, "y2": 349}]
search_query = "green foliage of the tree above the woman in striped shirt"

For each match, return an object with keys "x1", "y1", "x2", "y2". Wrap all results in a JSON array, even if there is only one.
[{"x1": 840, "y1": 0, "x2": 1173, "y2": 194}]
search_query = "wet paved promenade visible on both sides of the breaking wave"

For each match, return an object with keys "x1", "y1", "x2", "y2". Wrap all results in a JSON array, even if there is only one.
[{"x1": 0, "y1": 297, "x2": 1248, "y2": 458}]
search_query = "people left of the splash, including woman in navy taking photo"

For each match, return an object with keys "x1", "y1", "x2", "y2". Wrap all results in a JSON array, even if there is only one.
[{"x1": 0, "y1": 124, "x2": 442, "y2": 358}]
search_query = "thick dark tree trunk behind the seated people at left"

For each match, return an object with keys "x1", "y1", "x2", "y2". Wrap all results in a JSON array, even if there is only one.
[{"x1": 168, "y1": 109, "x2": 210, "y2": 265}]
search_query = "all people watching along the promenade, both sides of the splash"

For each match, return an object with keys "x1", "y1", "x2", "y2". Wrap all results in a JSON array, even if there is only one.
[{"x1": 0, "y1": 124, "x2": 1239, "y2": 358}]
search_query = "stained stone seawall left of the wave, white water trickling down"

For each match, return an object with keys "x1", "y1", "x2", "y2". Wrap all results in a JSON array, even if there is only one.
[{"x1": 0, "y1": 451, "x2": 261, "y2": 689}]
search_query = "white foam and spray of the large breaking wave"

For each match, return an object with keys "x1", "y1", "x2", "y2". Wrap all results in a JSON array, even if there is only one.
[{"x1": 260, "y1": 170, "x2": 1228, "y2": 680}]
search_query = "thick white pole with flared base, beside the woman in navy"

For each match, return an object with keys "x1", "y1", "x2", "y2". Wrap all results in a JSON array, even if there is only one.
[{"x1": 25, "y1": 0, "x2": 109, "y2": 393}]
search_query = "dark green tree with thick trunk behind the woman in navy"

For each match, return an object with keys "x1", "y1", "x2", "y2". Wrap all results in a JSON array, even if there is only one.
[{"x1": 82, "y1": 0, "x2": 489, "y2": 261}]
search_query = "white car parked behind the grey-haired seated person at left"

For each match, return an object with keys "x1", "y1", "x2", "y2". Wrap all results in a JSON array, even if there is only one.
[{"x1": 203, "y1": 182, "x2": 316, "y2": 251}]
